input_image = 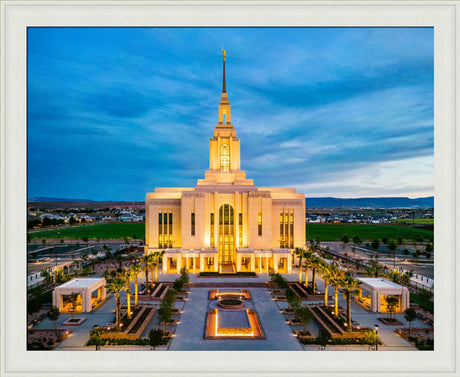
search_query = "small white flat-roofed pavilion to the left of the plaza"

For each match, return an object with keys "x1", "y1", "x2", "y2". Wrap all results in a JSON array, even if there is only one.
[{"x1": 53, "y1": 278, "x2": 106, "y2": 312}]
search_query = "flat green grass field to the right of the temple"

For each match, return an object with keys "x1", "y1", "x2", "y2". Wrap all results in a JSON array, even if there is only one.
[{"x1": 307, "y1": 224, "x2": 434, "y2": 241}]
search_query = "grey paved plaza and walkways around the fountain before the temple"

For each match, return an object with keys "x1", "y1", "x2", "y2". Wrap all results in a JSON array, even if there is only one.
[{"x1": 34, "y1": 274, "x2": 430, "y2": 351}]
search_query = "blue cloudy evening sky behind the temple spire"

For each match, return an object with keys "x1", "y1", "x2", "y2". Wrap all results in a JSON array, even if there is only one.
[{"x1": 28, "y1": 28, "x2": 434, "y2": 201}]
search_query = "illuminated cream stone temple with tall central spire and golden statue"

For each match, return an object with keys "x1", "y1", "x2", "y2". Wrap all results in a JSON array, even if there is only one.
[{"x1": 145, "y1": 51, "x2": 305, "y2": 273}]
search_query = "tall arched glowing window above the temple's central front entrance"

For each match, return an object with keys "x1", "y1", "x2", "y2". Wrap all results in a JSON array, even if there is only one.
[{"x1": 219, "y1": 204, "x2": 235, "y2": 265}]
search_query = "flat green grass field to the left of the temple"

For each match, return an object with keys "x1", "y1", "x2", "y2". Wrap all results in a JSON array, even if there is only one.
[{"x1": 29, "y1": 223, "x2": 145, "y2": 239}]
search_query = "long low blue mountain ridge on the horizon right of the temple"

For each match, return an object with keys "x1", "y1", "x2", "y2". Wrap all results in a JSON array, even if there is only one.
[{"x1": 306, "y1": 196, "x2": 434, "y2": 208}]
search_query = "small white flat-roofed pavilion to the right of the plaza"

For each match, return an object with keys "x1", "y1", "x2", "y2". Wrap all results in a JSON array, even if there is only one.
[{"x1": 357, "y1": 277, "x2": 410, "y2": 313}]
